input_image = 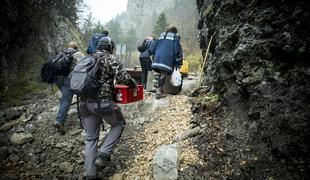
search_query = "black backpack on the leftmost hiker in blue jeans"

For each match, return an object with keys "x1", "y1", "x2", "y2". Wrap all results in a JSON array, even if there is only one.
[{"x1": 41, "y1": 50, "x2": 77, "y2": 83}]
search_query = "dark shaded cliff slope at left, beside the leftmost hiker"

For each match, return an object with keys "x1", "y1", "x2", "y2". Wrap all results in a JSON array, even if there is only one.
[{"x1": 0, "y1": 0, "x2": 85, "y2": 107}]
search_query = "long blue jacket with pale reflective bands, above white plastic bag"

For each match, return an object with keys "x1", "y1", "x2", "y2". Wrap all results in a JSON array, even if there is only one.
[{"x1": 151, "y1": 32, "x2": 183, "y2": 74}]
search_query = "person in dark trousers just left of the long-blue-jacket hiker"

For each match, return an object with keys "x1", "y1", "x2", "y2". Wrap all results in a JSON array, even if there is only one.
[{"x1": 138, "y1": 37, "x2": 155, "y2": 89}]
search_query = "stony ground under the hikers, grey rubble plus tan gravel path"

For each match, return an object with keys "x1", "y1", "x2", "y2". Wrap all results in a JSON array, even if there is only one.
[{"x1": 0, "y1": 79, "x2": 200, "y2": 179}]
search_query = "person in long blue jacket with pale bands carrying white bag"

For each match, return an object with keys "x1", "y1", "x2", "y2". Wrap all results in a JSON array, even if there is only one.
[{"x1": 152, "y1": 27, "x2": 183, "y2": 99}]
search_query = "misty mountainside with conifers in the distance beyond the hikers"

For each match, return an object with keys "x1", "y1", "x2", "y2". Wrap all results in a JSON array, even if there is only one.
[{"x1": 79, "y1": 0, "x2": 201, "y2": 72}]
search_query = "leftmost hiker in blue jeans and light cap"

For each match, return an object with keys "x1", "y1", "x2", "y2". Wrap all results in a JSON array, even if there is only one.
[{"x1": 53, "y1": 42, "x2": 84, "y2": 135}]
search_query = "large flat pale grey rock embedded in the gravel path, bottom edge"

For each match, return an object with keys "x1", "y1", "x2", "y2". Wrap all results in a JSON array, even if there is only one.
[{"x1": 153, "y1": 143, "x2": 181, "y2": 180}]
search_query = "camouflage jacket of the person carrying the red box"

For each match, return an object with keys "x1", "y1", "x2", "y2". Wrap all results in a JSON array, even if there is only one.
[{"x1": 95, "y1": 51, "x2": 137, "y2": 100}]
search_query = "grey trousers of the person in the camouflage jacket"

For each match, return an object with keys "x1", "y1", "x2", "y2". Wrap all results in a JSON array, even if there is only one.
[{"x1": 80, "y1": 100, "x2": 126, "y2": 176}]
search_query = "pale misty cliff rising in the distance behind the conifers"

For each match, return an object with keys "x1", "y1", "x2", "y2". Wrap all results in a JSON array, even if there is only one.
[{"x1": 116, "y1": 0, "x2": 198, "y2": 41}]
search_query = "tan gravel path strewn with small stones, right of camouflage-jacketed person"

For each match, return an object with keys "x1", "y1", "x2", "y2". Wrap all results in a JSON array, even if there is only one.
[{"x1": 110, "y1": 95, "x2": 198, "y2": 179}]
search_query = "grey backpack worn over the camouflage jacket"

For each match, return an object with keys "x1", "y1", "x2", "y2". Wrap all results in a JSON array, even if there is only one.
[{"x1": 69, "y1": 55, "x2": 101, "y2": 97}]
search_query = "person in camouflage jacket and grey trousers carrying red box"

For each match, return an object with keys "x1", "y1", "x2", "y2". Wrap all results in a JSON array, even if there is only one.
[{"x1": 80, "y1": 36, "x2": 137, "y2": 179}]
